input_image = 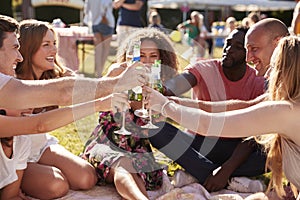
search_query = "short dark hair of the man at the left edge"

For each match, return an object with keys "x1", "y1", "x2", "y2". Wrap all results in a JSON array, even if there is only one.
[{"x1": 0, "y1": 15, "x2": 19, "y2": 48}]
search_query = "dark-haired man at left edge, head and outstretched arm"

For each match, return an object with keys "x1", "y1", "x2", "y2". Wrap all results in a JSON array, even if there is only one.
[{"x1": 0, "y1": 15, "x2": 147, "y2": 108}]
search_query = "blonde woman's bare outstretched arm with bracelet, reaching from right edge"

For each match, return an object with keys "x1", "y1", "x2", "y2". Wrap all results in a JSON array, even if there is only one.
[{"x1": 146, "y1": 87, "x2": 300, "y2": 141}]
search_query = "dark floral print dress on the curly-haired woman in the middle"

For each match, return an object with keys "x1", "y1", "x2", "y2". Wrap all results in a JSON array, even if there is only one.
[{"x1": 82, "y1": 110, "x2": 163, "y2": 190}]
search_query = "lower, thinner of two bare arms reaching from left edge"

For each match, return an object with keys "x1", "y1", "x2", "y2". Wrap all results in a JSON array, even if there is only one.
[{"x1": 0, "y1": 93, "x2": 129, "y2": 137}]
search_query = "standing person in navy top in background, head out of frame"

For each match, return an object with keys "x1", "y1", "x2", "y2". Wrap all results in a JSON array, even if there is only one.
[{"x1": 113, "y1": 0, "x2": 146, "y2": 44}]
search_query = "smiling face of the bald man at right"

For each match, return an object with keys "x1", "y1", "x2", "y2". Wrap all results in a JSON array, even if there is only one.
[{"x1": 245, "y1": 28, "x2": 277, "y2": 76}]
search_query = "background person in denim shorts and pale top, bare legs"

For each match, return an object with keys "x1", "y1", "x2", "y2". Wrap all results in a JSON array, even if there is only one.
[{"x1": 84, "y1": 0, "x2": 115, "y2": 77}]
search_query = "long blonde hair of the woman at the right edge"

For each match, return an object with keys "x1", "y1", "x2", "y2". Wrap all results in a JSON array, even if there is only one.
[{"x1": 261, "y1": 36, "x2": 300, "y2": 196}]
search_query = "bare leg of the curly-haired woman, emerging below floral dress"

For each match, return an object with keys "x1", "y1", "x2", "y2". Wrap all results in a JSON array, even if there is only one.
[{"x1": 107, "y1": 157, "x2": 149, "y2": 200}]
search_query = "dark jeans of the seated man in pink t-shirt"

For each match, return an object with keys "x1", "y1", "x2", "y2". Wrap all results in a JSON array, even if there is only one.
[{"x1": 149, "y1": 122, "x2": 266, "y2": 184}]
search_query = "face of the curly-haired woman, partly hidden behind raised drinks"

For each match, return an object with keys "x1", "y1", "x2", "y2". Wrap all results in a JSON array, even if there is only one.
[{"x1": 141, "y1": 39, "x2": 160, "y2": 64}]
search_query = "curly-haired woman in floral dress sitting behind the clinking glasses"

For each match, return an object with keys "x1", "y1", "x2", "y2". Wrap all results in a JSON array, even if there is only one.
[{"x1": 83, "y1": 28, "x2": 178, "y2": 200}]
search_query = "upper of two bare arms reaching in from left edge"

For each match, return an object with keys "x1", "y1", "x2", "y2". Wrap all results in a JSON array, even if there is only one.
[{"x1": 0, "y1": 63, "x2": 147, "y2": 109}]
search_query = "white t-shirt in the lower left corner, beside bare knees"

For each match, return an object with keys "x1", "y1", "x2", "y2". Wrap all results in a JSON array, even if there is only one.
[{"x1": 0, "y1": 135, "x2": 31, "y2": 189}]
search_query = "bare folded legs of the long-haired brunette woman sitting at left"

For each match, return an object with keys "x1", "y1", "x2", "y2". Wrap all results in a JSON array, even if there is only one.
[{"x1": 22, "y1": 145, "x2": 97, "y2": 199}]
